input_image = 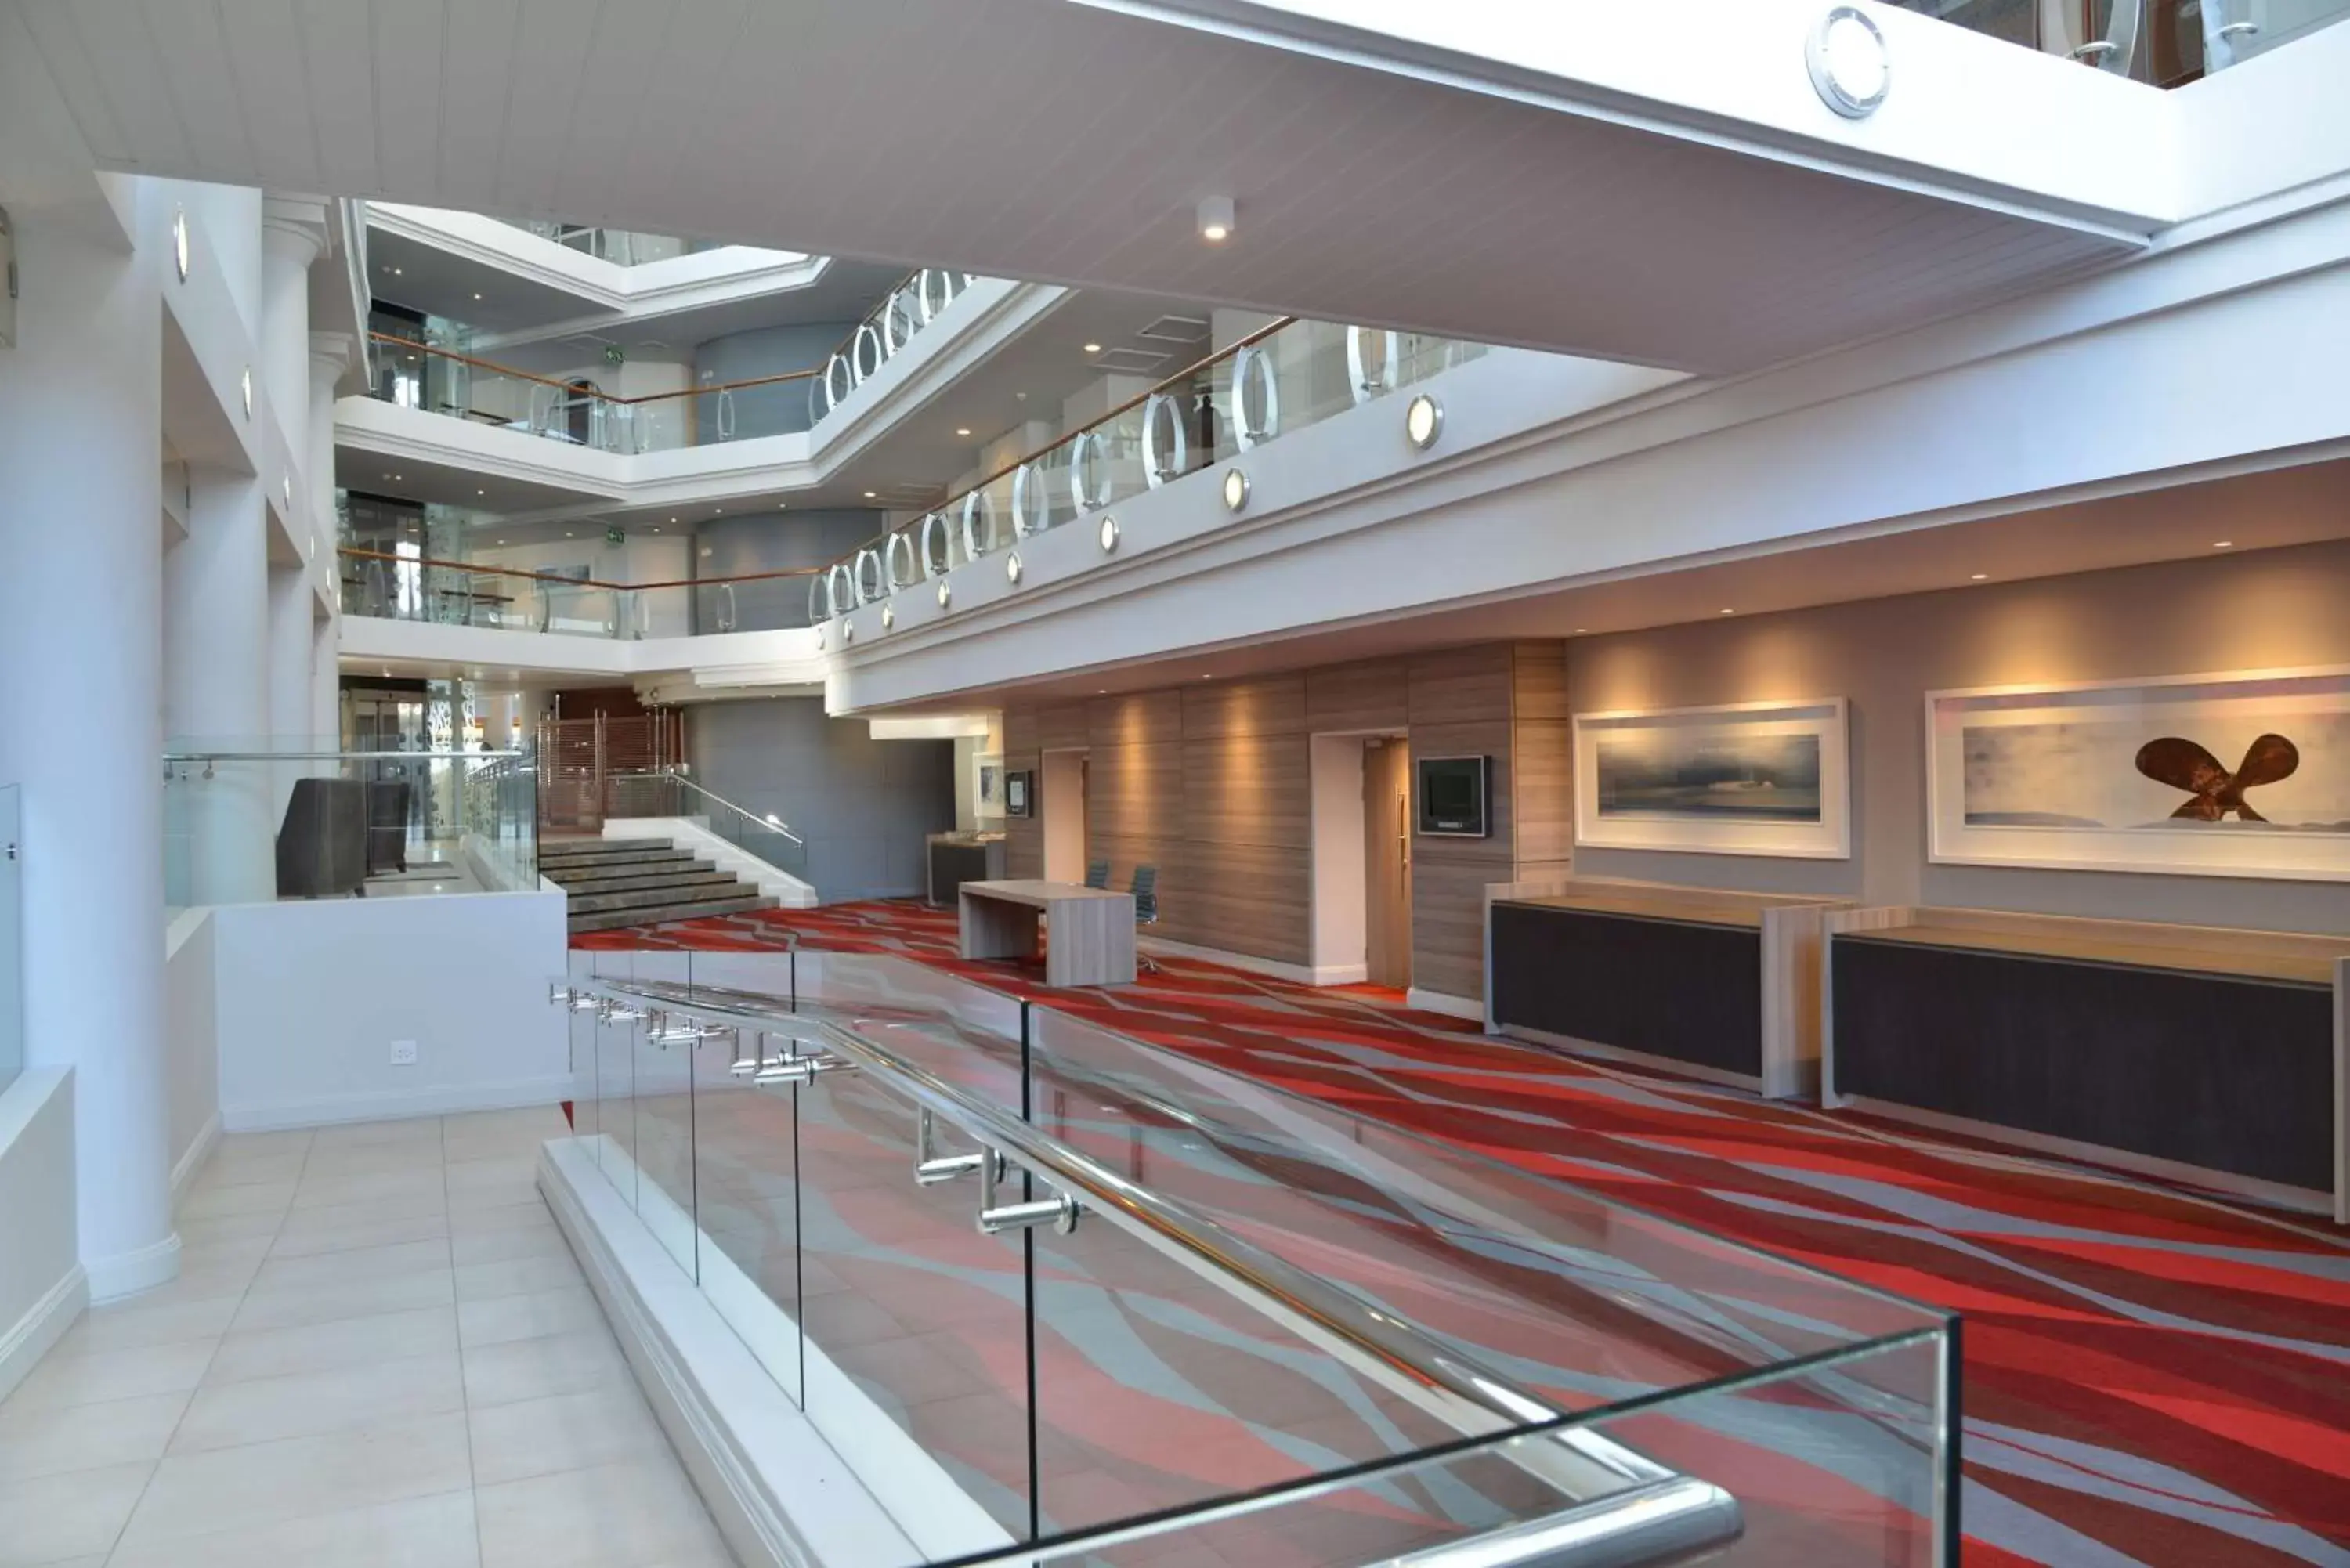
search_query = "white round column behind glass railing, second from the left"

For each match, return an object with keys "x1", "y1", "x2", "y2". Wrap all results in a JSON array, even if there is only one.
[{"x1": 162, "y1": 468, "x2": 277, "y2": 903}]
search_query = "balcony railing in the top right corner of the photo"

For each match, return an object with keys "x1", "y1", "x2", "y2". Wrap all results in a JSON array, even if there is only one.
[{"x1": 1889, "y1": 0, "x2": 2350, "y2": 87}]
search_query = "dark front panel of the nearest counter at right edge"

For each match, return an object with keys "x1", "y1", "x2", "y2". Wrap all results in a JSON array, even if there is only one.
[{"x1": 1833, "y1": 934, "x2": 2334, "y2": 1190}]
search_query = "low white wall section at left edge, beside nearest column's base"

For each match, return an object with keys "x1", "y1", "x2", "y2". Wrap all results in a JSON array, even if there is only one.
[{"x1": 0, "y1": 1068, "x2": 87, "y2": 1399}]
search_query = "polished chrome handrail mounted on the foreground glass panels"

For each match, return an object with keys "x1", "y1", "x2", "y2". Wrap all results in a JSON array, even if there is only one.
[{"x1": 555, "y1": 976, "x2": 1741, "y2": 1532}]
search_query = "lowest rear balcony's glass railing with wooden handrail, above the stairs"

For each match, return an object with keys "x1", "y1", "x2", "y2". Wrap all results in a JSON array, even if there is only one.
[{"x1": 336, "y1": 545, "x2": 818, "y2": 639}]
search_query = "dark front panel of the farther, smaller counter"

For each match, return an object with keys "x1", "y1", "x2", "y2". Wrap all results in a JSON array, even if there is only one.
[{"x1": 1492, "y1": 903, "x2": 1762, "y2": 1077}]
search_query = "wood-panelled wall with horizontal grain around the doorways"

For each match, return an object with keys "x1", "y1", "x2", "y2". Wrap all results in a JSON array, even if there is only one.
[{"x1": 1003, "y1": 641, "x2": 1572, "y2": 997}]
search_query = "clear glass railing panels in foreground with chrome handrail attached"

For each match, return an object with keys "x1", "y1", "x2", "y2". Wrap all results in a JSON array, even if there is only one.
[{"x1": 550, "y1": 950, "x2": 1958, "y2": 1568}]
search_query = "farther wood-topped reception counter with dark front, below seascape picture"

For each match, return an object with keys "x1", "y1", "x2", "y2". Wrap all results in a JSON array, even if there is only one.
[{"x1": 1485, "y1": 882, "x2": 1845, "y2": 1098}]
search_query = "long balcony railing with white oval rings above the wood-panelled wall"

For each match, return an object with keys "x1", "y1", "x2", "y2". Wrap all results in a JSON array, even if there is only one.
[{"x1": 808, "y1": 317, "x2": 1485, "y2": 623}]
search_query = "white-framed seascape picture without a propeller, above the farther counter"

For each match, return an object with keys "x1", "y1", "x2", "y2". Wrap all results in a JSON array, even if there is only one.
[{"x1": 1574, "y1": 695, "x2": 1852, "y2": 861}]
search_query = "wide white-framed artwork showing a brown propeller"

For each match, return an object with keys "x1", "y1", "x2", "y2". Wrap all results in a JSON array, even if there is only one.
[{"x1": 1925, "y1": 665, "x2": 2350, "y2": 882}]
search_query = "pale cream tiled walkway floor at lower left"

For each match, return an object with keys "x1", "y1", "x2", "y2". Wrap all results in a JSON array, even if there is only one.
[{"x1": 0, "y1": 1107, "x2": 733, "y2": 1568}]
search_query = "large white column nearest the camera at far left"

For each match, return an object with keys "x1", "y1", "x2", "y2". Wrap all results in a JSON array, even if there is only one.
[{"x1": 0, "y1": 196, "x2": 179, "y2": 1300}]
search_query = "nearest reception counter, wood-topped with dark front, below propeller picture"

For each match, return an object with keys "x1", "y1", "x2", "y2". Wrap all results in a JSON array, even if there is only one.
[{"x1": 1821, "y1": 908, "x2": 2350, "y2": 1220}]
